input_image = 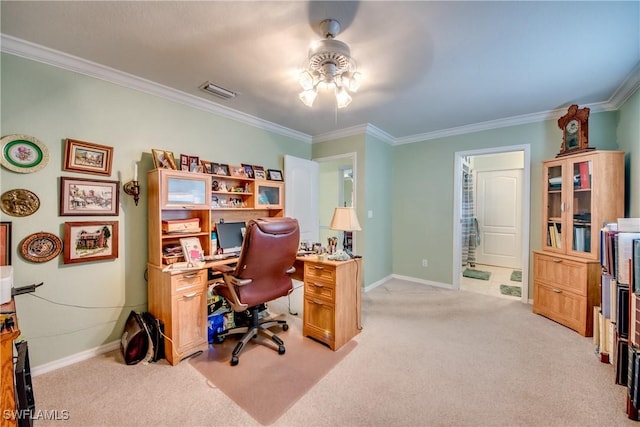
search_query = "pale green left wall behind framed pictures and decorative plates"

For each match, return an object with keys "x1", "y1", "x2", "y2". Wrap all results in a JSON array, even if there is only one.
[{"x1": 0, "y1": 54, "x2": 311, "y2": 366}]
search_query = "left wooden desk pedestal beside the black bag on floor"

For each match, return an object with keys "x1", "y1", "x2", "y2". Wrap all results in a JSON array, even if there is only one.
[{"x1": 149, "y1": 266, "x2": 208, "y2": 365}]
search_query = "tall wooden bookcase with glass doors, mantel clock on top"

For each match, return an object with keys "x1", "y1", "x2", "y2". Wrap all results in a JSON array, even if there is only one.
[{"x1": 533, "y1": 151, "x2": 624, "y2": 336}]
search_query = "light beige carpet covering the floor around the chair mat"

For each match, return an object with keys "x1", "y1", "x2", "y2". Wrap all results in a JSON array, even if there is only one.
[{"x1": 27, "y1": 279, "x2": 639, "y2": 427}]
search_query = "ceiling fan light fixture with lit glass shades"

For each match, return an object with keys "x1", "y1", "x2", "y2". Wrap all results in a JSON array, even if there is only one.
[{"x1": 299, "y1": 19, "x2": 361, "y2": 108}]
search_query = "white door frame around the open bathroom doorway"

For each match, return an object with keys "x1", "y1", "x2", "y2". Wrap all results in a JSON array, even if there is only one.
[{"x1": 453, "y1": 144, "x2": 531, "y2": 304}]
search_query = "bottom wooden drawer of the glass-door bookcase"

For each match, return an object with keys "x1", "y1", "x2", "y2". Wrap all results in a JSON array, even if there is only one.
[{"x1": 533, "y1": 282, "x2": 593, "y2": 336}]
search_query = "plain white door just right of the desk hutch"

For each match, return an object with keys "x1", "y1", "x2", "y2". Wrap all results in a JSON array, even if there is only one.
[{"x1": 284, "y1": 155, "x2": 320, "y2": 242}]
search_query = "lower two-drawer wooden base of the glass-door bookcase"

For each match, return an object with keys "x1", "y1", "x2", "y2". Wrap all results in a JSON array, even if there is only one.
[{"x1": 533, "y1": 251, "x2": 601, "y2": 337}]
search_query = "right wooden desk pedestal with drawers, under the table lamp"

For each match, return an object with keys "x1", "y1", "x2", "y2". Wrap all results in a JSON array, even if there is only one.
[{"x1": 302, "y1": 259, "x2": 362, "y2": 350}]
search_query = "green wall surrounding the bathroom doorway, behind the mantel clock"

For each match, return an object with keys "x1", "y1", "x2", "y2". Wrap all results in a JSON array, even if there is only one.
[{"x1": 392, "y1": 112, "x2": 619, "y2": 295}]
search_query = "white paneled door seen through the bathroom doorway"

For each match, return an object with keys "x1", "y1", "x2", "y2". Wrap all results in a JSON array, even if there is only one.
[{"x1": 476, "y1": 169, "x2": 522, "y2": 268}]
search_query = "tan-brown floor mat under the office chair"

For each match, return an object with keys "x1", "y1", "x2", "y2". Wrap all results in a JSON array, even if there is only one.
[{"x1": 189, "y1": 316, "x2": 357, "y2": 425}]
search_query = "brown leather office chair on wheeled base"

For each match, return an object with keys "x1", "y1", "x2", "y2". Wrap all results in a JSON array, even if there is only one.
[{"x1": 215, "y1": 218, "x2": 300, "y2": 365}]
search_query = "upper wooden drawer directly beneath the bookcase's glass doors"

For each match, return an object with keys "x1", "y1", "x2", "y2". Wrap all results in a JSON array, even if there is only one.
[{"x1": 533, "y1": 253, "x2": 587, "y2": 295}]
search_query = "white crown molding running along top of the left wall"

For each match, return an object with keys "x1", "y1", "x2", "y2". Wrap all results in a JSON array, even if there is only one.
[{"x1": 0, "y1": 34, "x2": 311, "y2": 143}]
